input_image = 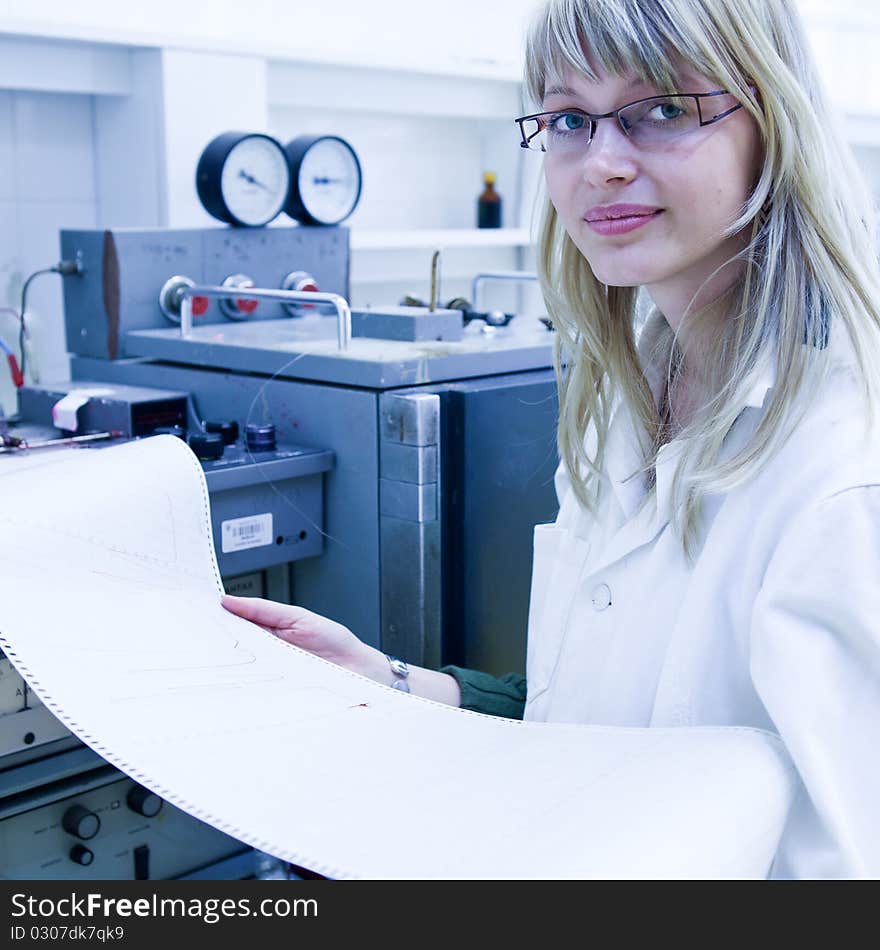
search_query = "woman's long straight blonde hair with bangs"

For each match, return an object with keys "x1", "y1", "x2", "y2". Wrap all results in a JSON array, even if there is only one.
[{"x1": 526, "y1": 0, "x2": 880, "y2": 555}]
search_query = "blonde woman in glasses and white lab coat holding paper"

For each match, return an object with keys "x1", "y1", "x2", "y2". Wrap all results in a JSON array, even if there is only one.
[{"x1": 224, "y1": 0, "x2": 880, "y2": 877}]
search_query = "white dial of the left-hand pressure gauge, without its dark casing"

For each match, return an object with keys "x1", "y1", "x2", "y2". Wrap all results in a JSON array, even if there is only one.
[{"x1": 220, "y1": 135, "x2": 290, "y2": 227}]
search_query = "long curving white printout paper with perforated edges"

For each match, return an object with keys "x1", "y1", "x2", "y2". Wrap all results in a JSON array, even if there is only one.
[{"x1": 0, "y1": 436, "x2": 796, "y2": 879}]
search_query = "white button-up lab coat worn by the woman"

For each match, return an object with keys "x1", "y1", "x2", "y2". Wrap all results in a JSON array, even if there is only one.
[{"x1": 525, "y1": 317, "x2": 880, "y2": 878}]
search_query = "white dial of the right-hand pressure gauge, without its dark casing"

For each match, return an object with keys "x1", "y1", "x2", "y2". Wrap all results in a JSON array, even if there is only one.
[{"x1": 297, "y1": 137, "x2": 361, "y2": 224}]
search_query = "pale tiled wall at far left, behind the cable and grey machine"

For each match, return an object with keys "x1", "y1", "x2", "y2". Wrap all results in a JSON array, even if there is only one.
[{"x1": 0, "y1": 90, "x2": 98, "y2": 412}]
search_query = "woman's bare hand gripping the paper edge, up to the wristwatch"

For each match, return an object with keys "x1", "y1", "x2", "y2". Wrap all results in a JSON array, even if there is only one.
[{"x1": 221, "y1": 594, "x2": 391, "y2": 683}]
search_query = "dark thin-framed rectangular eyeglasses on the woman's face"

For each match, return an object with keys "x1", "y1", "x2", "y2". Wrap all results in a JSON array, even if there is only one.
[{"x1": 515, "y1": 89, "x2": 742, "y2": 154}]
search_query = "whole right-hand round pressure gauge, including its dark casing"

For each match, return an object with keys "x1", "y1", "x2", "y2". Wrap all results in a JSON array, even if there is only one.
[{"x1": 284, "y1": 135, "x2": 361, "y2": 224}]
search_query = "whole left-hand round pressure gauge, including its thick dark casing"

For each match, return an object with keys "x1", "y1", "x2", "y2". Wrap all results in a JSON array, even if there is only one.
[{"x1": 196, "y1": 132, "x2": 290, "y2": 228}]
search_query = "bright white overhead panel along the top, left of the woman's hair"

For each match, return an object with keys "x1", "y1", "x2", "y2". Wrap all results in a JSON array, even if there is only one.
[{"x1": 0, "y1": 0, "x2": 538, "y2": 82}]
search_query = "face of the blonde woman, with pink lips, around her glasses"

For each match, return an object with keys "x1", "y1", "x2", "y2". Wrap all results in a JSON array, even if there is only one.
[{"x1": 543, "y1": 58, "x2": 760, "y2": 304}]
